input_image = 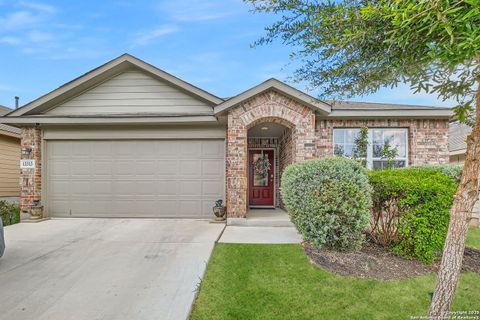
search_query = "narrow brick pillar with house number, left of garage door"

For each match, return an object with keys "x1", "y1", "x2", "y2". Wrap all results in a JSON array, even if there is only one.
[{"x1": 20, "y1": 127, "x2": 42, "y2": 212}]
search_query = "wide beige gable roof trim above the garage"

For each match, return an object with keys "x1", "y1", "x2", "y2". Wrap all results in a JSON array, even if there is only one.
[{"x1": 7, "y1": 54, "x2": 224, "y2": 116}]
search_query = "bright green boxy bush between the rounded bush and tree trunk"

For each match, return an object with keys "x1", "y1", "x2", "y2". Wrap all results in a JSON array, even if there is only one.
[{"x1": 369, "y1": 168, "x2": 456, "y2": 263}]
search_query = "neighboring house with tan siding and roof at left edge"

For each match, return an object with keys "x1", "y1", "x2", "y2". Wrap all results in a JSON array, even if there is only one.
[{"x1": 0, "y1": 106, "x2": 20, "y2": 201}]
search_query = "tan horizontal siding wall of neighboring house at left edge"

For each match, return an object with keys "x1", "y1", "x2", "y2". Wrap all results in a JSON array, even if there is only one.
[{"x1": 0, "y1": 135, "x2": 20, "y2": 197}]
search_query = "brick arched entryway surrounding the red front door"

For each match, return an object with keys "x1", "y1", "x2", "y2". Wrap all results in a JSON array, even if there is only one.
[{"x1": 226, "y1": 90, "x2": 315, "y2": 218}]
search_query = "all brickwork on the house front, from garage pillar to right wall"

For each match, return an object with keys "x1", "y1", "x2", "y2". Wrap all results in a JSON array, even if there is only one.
[{"x1": 15, "y1": 107, "x2": 449, "y2": 217}]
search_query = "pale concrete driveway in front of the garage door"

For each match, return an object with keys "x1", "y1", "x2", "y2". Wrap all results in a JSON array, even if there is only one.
[{"x1": 0, "y1": 219, "x2": 223, "y2": 320}]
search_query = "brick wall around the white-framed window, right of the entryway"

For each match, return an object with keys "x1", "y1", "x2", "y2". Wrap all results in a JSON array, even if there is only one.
[{"x1": 315, "y1": 119, "x2": 449, "y2": 165}]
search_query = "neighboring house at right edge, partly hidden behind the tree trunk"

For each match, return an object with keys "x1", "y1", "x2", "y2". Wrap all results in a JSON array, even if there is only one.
[{"x1": 448, "y1": 121, "x2": 480, "y2": 227}]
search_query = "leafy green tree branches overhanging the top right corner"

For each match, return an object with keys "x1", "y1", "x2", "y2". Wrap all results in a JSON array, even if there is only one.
[{"x1": 245, "y1": 0, "x2": 480, "y2": 121}]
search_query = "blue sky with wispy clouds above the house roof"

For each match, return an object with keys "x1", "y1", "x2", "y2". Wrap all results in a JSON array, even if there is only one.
[{"x1": 0, "y1": 0, "x2": 452, "y2": 107}]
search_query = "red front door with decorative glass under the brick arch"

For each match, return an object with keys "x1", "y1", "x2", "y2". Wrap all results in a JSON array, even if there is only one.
[{"x1": 248, "y1": 150, "x2": 275, "y2": 206}]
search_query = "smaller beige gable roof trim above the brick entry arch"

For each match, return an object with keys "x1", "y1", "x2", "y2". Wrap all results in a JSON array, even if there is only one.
[{"x1": 214, "y1": 78, "x2": 331, "y2": 114}]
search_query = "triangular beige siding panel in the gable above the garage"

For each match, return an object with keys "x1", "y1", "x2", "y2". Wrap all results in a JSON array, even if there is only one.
[{"x1": 45, "y1": 70, "x2": 213, "y2": 115}]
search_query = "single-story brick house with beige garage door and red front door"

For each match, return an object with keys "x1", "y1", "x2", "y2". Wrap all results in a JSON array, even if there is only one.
[{"x1": 2, "y1": 54, "x2": 452, "y2": 219}]
